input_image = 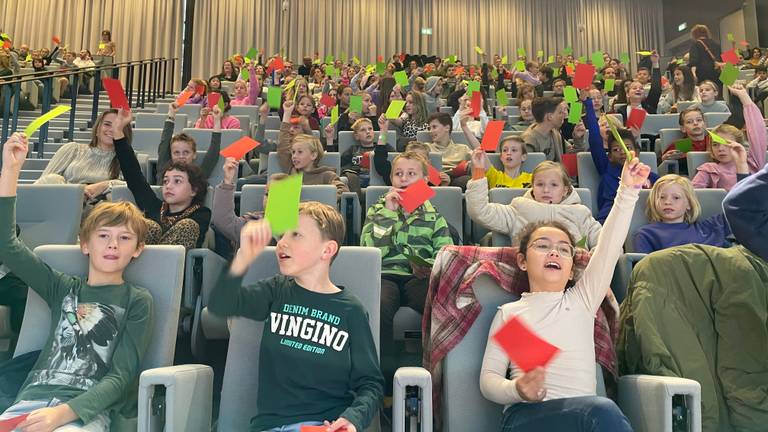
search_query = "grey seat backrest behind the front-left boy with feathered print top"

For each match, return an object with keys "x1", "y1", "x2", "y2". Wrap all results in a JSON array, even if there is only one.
[{"x1": 14, "y1": 245, "x2": 185, "y2": 370}]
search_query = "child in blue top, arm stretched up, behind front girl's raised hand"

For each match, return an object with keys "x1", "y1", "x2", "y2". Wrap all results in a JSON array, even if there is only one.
[{"x1": 581, "y1": 91, "x2": 659, "y2": 223}]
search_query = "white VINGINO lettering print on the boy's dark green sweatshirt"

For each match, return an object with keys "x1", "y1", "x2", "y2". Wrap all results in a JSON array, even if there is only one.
[{"x1": 269, "y1": 303, "x2": 349, "y2": 355}]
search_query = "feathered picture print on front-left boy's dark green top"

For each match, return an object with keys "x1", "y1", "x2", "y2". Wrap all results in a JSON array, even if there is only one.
[{"x1": 30, "y1": 291, "x2": 125, "y2": 390}]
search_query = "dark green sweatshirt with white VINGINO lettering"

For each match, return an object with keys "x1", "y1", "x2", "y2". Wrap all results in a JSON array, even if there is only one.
[{"x1": 208, "y1": 272, "x2": 384, "y2": 431}]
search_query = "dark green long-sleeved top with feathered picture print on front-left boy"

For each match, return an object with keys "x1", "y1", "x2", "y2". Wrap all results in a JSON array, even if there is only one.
[{"x1": 0, "y1": 197, "x2": 153, "y2": 424}]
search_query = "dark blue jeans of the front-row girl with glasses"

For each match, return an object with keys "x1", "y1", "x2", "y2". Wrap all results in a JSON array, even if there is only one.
[{"x1": 501, "y1": 396, "x2": 632, "y2": 432}]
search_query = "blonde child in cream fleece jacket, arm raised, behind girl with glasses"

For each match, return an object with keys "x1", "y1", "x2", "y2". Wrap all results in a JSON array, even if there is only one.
[{"x1": 464, "y1": 158, "x2": 601, "y2": 249}]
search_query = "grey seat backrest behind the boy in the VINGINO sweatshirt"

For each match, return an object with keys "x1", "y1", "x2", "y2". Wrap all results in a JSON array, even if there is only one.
[{"x1": 218, "y1": 246, "x2": 381, "y2": 431}]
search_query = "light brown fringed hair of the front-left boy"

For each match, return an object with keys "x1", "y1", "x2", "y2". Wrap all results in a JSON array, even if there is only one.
[{"x1": 80, "y1": 201, "x2": 149, "y2": 248}]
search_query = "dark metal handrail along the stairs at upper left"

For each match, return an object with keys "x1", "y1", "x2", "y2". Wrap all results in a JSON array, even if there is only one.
[{"x1": 0, "y1": 57, "x2": 178, "y2": 154}]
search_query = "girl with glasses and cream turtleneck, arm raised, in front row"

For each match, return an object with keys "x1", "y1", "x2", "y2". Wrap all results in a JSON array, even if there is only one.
[{"x1": 480, "y1": 159, "x2": 650, "y2": 432}]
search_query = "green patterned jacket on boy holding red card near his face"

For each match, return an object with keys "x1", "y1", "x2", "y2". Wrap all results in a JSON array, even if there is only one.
[{"x1": 360, "y1": 195, "x2": 453, "y2": 276}]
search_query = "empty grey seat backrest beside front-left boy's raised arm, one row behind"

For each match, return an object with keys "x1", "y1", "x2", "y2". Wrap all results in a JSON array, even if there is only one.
[{"x1": 16, "y1": 184, "x2": 84, "y2": 248}]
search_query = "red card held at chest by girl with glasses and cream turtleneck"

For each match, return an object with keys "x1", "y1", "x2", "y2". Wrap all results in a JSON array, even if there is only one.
[{"x1": 493, "y1": 316, "x2": 560, "y2": 372}]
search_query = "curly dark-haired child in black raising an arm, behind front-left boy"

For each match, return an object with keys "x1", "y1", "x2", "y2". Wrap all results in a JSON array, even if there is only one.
[{"x1": 112, "y1": 110, "x2": 211, "y2": 249}]
